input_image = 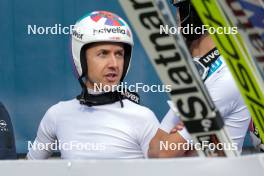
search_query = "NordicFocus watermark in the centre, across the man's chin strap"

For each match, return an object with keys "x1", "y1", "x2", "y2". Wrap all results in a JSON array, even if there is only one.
[{"x1": 93, "y1": 82, "x2": 171, "y2": 93}]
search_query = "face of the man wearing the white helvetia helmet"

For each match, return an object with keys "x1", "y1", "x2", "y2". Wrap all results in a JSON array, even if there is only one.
[{"x1": 86, "y1": 42, "x2": 125, "y2": 89}]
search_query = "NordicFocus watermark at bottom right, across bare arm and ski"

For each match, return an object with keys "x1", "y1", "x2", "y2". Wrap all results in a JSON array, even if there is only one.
[{"x1": 159, "y1": 140, "x2": 238, "y2": 151}]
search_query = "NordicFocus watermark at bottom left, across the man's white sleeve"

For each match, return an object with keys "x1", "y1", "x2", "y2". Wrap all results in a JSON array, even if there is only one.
[{"x1": 27, "y1": 141, "x2": 106, "y2": 151}]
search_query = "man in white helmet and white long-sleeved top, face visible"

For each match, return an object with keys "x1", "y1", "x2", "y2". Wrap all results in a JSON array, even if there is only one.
[{"x1": 27, "y1": 11, "x2": 159, "y2": 159}]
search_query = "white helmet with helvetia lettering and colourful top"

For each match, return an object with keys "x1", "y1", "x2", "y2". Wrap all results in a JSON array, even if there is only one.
[{"x1": 71, "y1": 11, "x2": 134, "y2": 81}]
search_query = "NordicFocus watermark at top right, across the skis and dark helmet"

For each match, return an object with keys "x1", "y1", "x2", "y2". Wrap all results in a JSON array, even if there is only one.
[{"x1": 160, "y1": 24, "x2": 238, "y2": 35}]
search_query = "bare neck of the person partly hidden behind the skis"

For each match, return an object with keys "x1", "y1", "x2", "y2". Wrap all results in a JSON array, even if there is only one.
[{"x1": 190, "y1": 34, "x2": 216, "y2": 57}]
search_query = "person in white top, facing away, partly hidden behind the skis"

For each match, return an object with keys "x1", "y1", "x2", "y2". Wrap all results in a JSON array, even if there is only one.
[{"x1": 149, "y1": 0, "x2": 250, "y2": 157}]
